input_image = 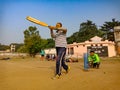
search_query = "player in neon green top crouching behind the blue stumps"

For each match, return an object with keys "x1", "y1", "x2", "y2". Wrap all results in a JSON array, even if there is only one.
[{"x1": 88, "y1": 51, "x2": 100, "y2": 68}]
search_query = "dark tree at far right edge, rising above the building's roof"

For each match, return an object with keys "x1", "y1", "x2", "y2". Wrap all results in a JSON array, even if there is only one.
[{"x1": 100, "y1": 19, "x2": 120, "y2": 41}]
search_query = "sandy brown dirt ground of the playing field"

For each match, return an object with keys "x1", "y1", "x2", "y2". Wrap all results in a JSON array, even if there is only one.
[{"x1": 0, "y1": 58, "x2": 120, "y2": 90}]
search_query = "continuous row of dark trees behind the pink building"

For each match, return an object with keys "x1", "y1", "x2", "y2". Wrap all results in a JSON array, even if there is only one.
[{"x1": 67, "y1": 19, "x2": 120, "y2": 44}]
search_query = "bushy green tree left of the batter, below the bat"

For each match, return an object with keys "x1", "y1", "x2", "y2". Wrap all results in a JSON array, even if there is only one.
[{"x1": 24, "y1": 26, "x2": 47, "y2": 57}]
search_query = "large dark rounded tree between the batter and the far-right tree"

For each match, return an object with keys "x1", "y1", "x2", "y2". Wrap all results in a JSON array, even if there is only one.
[{"x1": 67, "y1": 20, "x2": 103, "y2": 43}]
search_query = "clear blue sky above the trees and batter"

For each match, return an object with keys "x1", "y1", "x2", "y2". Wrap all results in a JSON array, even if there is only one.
[{"x1": 0, "y1": 0, "x2": 120, "y2": 45}]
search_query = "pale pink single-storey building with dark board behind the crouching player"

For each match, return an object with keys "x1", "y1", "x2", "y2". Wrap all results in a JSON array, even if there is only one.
[{"x1": 66, "y1": 36, "x2": 116, "y2": 57}]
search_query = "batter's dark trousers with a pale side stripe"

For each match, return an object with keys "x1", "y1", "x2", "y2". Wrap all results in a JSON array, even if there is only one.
[{"x1": 56, "y1": 47, "x2": 68, "y2": 75}]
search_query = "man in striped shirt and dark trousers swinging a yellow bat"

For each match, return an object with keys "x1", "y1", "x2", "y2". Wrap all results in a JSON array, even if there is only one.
[{"x1": 49, "y1": 22, "x2": 70, "y2": 78}]
